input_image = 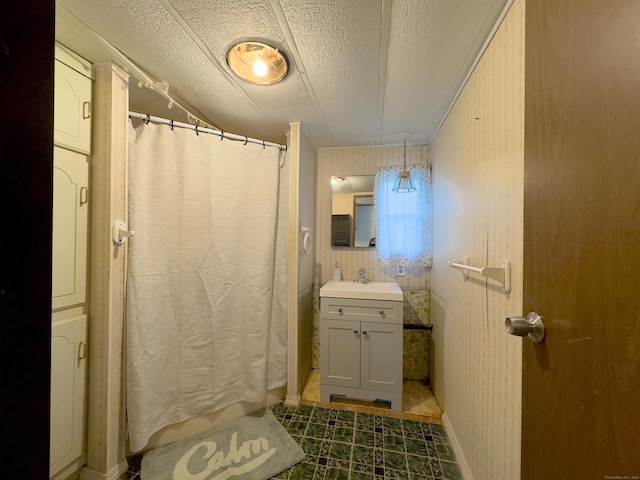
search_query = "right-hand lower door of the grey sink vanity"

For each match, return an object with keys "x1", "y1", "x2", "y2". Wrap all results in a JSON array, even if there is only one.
[{"x1": 360, "y1": 322, "x2": 402, "y2": 392}]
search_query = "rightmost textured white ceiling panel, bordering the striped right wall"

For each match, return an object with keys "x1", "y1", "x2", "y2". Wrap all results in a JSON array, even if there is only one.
[{"x1": 383, "y1": 0, "x2": 504, "y2": 143}]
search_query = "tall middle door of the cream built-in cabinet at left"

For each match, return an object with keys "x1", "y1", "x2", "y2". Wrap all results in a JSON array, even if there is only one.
[{"x1": 52, "y1": 147, "x2": 89, "y2": 309}]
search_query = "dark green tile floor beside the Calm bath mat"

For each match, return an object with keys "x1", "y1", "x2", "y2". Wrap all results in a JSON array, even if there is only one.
[{"x1": 120, "y1": 403, "x2": 462, "y2": 480}]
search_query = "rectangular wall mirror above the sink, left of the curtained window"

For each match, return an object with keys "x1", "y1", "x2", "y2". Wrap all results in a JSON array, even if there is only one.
[{"x1": 331, "y1": 175, "x2": 376, "y2": 248}]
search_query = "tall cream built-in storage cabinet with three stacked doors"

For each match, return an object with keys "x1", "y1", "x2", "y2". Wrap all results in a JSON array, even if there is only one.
[{"x1": 49, "y1": 45, "x2": 92, "y2": 480}]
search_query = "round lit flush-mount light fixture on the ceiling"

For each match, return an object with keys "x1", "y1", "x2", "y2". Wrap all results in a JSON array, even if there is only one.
[{"x1": 227, "y1": 41, "x2": 289, "y2": 85}]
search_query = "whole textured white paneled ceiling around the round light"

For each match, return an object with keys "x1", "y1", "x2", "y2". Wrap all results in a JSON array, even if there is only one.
[{"x1": 56, "y1": 0, "x2": 508, "y2": 148}]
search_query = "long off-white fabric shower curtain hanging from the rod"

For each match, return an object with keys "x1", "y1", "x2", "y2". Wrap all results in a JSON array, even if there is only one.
[{"x1": 126, "y1": 123, "x2": 287, "y2": 451}]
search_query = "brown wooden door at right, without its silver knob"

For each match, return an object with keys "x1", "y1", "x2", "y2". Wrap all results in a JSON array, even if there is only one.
[{"x1": 522, "y1": 0, "x2": 640, "y2": 480}]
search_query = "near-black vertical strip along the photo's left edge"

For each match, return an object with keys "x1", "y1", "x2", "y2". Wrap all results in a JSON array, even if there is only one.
[{"x1": 0, "y1": 0, "x2": 55, "y2": 480}]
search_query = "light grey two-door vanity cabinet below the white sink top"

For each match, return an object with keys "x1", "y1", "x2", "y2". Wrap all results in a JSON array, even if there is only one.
[{"x1": 320, "y1": 297, "x2": 402, "y2": 411}]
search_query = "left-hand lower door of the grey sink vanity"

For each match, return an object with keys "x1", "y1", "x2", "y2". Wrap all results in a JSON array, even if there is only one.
[{"x1": 320, "y1": 319, "x2": 361, "y2": 388}]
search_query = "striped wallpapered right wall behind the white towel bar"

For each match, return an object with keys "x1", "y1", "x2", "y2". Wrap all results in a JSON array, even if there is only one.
[{"x1": 431, "y1": 0, "x2": 527, "y2": 479}]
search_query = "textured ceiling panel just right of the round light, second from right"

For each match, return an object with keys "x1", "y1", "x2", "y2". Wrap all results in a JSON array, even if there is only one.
[{"x1": 280, "y1": 0, "x2": 382, "y2": 146}]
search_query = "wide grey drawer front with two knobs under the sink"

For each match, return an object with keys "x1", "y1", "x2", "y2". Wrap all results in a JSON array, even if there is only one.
[{"x1": 320, "y1": 297, "x2": 402, "y2": 324}]
